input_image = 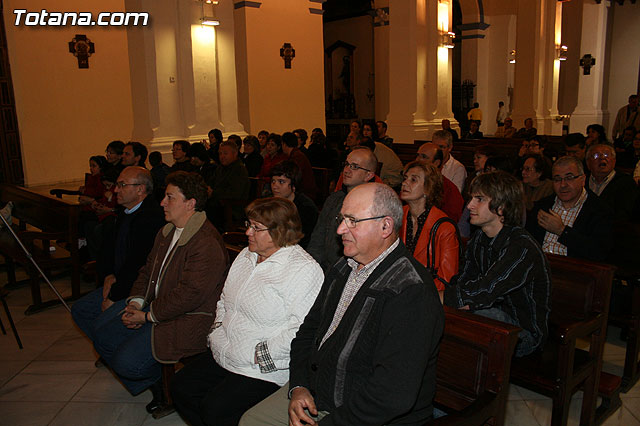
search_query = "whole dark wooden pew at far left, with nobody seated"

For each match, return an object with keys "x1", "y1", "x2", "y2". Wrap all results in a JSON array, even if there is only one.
[{"x1": 0, "y1": 184, "x2": 80, "y2": 315}]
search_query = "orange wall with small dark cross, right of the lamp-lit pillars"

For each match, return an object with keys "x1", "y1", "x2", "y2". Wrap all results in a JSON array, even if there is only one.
[{"x1": 234, "y1": 1, "x2": 325, "y2": 134}]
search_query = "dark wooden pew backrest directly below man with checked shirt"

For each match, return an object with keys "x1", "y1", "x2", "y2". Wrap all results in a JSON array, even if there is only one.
[{"x1": 547, "y1": 254, "x2": 615, "y2": 321}]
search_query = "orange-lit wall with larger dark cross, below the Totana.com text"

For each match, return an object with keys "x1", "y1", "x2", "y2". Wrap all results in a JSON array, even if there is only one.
[{"x1": 4, "y1": 0, "x2": 133, "y2": 186}]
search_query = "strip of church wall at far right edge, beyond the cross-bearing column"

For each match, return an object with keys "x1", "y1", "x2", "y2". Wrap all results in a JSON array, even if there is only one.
[{"x1": 604, "y1": 2, "x2": 640, "y2": 137}]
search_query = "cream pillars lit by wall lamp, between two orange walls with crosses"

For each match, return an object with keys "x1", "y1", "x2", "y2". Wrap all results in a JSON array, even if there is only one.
[{"x1": 127, "y1": 0, "x2": 244, "y2": 161}]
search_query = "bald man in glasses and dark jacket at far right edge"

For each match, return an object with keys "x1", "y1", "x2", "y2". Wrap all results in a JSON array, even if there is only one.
[{"x1": 587, "y1": 144, "x2": 638, "y2": 222}]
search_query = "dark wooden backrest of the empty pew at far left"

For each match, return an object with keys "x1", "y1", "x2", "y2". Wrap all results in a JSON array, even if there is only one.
[{"x1": 0, "y1": 184, "x2": 80, "y2": 242}]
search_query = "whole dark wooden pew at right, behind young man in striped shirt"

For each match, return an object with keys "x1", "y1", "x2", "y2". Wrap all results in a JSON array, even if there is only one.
[{"x1": 511, "y1": 255, "x2": 615, "y2": 426}]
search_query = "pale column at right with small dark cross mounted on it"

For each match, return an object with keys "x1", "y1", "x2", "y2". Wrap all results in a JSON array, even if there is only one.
[{"x1": 569, "y1": 2, "x2": 609, "y2": 134}]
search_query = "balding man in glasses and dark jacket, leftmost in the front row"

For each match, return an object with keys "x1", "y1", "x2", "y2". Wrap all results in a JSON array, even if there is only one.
[{"x1": 71, "y1": 167, "x2": 165, "y2": 364}]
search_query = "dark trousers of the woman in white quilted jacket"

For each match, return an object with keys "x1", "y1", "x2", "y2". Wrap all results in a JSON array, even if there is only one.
[{"x1": 171, "y1": 352, "x2": 280, "y2": 426}]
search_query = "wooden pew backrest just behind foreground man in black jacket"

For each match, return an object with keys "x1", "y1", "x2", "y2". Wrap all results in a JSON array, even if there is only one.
[{"x1": 435, "y1": 306, "x2": 520, "y2": 411}]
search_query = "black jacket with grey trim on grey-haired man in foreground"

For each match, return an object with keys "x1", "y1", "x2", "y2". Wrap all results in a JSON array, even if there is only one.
[{"x1": 289, "y1": 242, "x2": 444, "y2": 426}]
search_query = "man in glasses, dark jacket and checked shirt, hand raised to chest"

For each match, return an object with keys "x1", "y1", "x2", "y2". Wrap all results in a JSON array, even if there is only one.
[{"x1": 527, "y1": 156, "x2": 612, "y2": 261}]
